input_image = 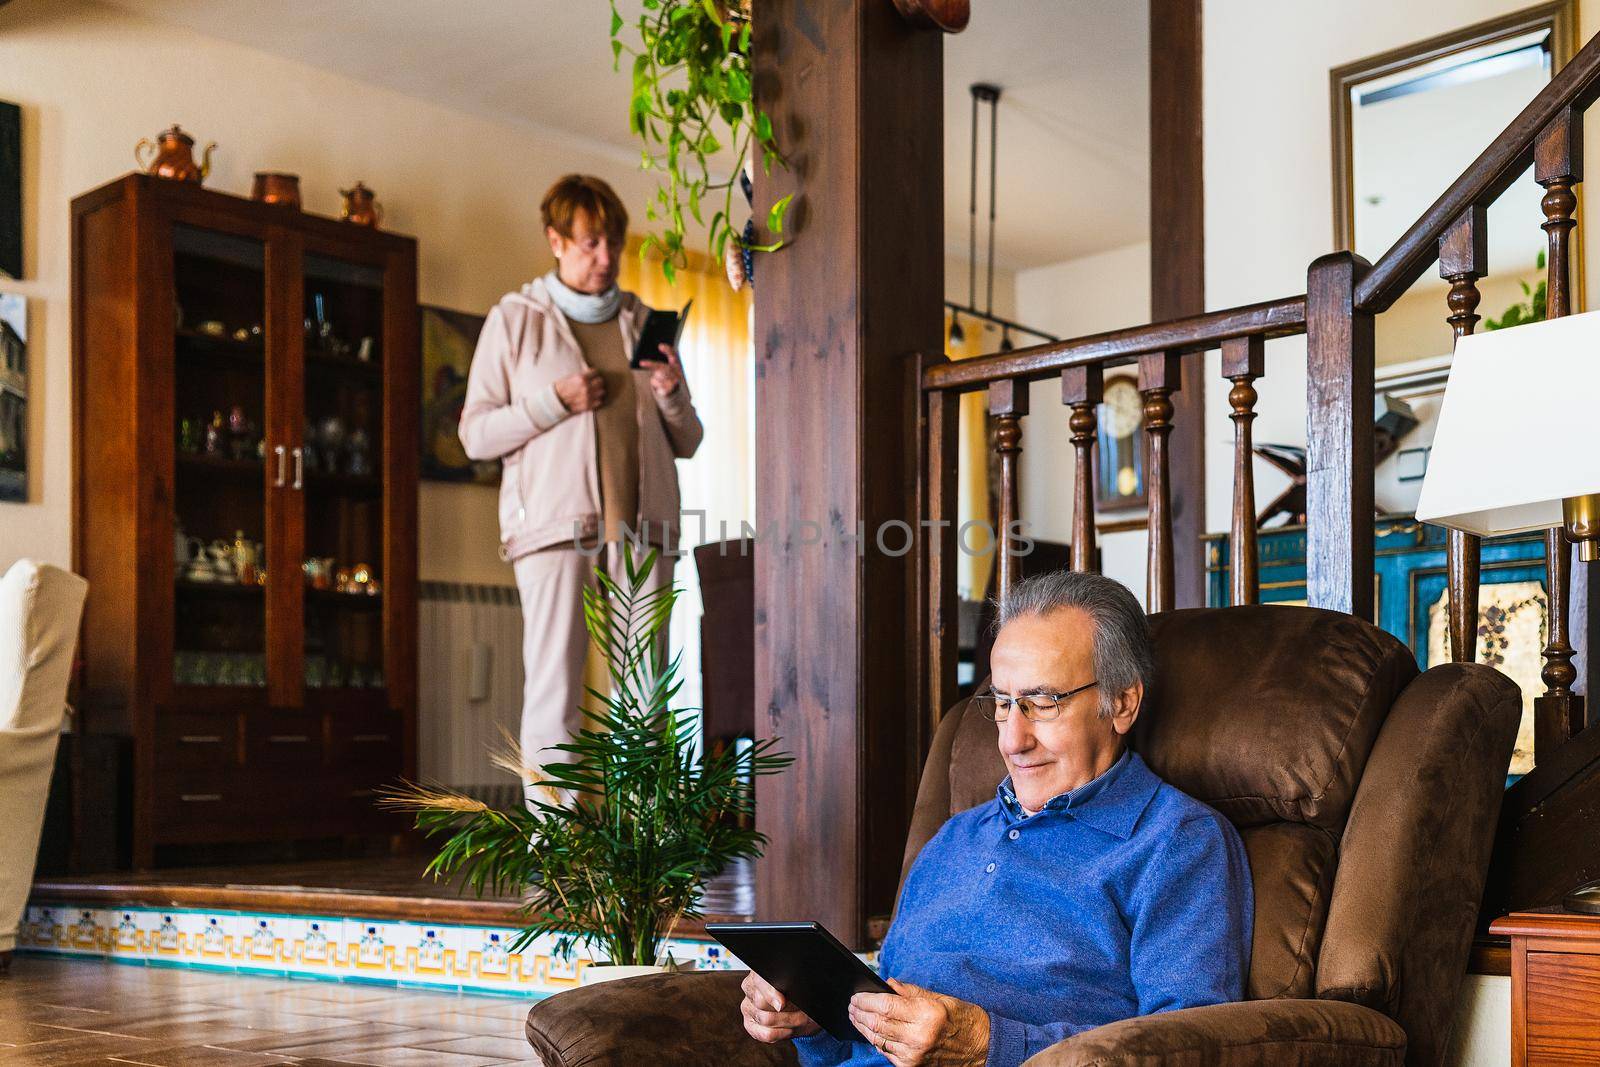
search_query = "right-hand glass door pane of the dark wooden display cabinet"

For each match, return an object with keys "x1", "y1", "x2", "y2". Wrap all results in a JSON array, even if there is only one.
[{"x1": 299, "y1": 251, "x2": 386, "y2": 707}]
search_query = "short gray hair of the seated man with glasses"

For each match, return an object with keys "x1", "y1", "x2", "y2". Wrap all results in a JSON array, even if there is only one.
[{"x1": 995, "y1": 571, "x2": 1155, "y2": 718}]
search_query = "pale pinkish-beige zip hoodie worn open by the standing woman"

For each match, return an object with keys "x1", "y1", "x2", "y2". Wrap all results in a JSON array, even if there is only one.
[{"x1": 459, "y1": 278, "x2": 704, "y2": 560}]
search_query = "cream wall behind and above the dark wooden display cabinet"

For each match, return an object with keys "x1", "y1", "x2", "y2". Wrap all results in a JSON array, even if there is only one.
[{"x1": 0, "y1": 0, "x2": 648, "y2": 582}]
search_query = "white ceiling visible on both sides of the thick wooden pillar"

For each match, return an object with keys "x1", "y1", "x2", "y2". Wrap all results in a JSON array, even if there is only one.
[{"x1": 100, "y1": 0, "x2": 1149, "y2": 275}]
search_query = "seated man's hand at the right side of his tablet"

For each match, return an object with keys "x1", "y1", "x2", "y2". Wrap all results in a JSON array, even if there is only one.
[{"x1": 850, "y1": 977, "x2": 989, "y2": 1067}]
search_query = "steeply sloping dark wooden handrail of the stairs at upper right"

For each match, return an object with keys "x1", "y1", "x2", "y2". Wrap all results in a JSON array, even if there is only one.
[{"x1": 1355, "y1": 25, "x2": 1600, "y2": 312}]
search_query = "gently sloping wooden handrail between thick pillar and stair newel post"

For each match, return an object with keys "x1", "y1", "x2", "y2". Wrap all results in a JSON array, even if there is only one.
[{"x1": 922, "y1": 296, "x2": 1306, "y2": 392}]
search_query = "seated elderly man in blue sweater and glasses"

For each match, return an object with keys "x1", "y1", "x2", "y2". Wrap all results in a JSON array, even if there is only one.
[{"x1": 741, "y1": 573, "x2": 1254, "y2": 1067}]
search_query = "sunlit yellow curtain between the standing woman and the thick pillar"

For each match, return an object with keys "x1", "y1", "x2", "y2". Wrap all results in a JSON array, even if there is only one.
[{"x1": 614, "y1": 237, "x2": 755, "y2": 723}]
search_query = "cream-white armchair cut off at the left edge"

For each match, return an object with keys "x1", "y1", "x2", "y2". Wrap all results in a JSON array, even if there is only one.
[{"x1": 0, "y1": 560, "x2": 90, "y2": 974}]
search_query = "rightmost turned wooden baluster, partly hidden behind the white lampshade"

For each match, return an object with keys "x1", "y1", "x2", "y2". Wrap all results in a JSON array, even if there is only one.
[{"x1": 1529, "y1": 107, "x2": 1584, "y2": 763}]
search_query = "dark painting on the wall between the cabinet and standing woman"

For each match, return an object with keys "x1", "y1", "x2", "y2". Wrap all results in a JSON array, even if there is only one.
[{"x1": 421, "y1": 306, "x2": 501, "y2": 485}]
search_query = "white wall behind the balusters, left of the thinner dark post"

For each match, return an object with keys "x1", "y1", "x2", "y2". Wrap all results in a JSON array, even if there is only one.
[{"x1": 1016, "y1": 242, "x2": 1150, "y2": 600}]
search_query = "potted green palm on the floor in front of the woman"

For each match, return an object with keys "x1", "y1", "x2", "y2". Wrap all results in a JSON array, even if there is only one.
[{"x1": 384, "y1": 550, "x2": 792, "y2": 981}]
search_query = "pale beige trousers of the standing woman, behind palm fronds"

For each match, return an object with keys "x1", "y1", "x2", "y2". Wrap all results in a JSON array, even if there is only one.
[{"x1": 512, "y1": 544, "x2": 675, "y2": 800}]
